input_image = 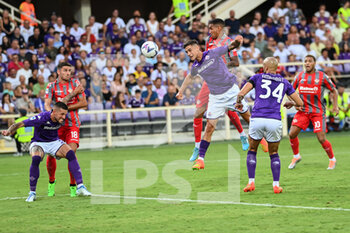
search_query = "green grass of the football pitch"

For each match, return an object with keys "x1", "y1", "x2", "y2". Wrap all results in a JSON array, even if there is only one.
[{"x1": 0, "y1": 133, "x2": 350, "y2": 232}]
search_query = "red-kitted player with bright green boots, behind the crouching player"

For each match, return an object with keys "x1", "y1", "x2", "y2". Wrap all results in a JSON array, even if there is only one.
[{"x1": 45, "y1": 62, "x2": 87, "y2": 197}]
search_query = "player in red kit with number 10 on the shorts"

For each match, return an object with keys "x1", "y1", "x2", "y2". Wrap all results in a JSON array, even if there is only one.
[{"x1": 287, "y1": 55, "x2": 339, "y2": 170}]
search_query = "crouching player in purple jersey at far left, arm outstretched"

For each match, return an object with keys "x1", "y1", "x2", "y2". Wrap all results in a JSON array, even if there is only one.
[{"x1": 2, "y1": 102, "x2": 91, "y2": 202}]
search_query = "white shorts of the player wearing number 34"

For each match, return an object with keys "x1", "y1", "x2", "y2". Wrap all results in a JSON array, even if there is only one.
[{"x1": 249, "y1": 118, "x2": 282, "y2": 142}]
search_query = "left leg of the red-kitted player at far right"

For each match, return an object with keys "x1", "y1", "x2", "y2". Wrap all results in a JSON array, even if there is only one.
[{"x1": 288, "y1": 111, "x2": 310, "y2": 169}]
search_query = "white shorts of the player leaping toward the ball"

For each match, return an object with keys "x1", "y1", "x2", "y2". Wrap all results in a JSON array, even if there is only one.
[{"x1": 207, "y1": 84, "x2": 249, "y2": 119}]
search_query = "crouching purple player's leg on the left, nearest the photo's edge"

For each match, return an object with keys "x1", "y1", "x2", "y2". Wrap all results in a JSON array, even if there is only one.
[{"x1": 26, "y1": 143, "x2": 44, "y2": 202}]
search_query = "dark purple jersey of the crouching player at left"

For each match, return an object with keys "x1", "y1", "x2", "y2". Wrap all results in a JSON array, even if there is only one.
[{"x1": 23, "y1": 112, "x2": 61, "y2": 142}]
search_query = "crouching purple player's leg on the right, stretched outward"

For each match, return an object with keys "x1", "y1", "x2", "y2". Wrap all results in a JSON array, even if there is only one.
[{"x1": 56, "y1": 144, "x2": 91, "y2": 196}]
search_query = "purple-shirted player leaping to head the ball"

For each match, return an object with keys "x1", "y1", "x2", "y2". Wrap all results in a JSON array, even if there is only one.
[{"x1": 177, "y1": 39, "x2": 250, "y2": 170}]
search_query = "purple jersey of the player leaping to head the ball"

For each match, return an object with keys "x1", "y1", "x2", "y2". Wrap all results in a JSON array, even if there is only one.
[{"x1": 191, "y1": 46, "x2": 236, "y2": 95}]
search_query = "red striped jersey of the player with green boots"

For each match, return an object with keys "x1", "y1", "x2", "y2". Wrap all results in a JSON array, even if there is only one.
[{"x1": 45, "y1": 79, "x2": 85, "y2": 127}]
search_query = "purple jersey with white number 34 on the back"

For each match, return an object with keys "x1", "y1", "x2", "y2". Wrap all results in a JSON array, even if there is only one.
[{"x1": 248, "y1": 74, "x2": 295, "y2": 120}]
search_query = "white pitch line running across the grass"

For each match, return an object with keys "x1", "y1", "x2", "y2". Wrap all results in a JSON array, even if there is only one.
[{"x1": 0, "y1": 194, "x2": 350, "y2": 212}]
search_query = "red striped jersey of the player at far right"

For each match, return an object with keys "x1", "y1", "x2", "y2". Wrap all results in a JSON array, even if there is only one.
[{"x1": 293, "y1": 71, "x2": 335, "y2": 115}]
